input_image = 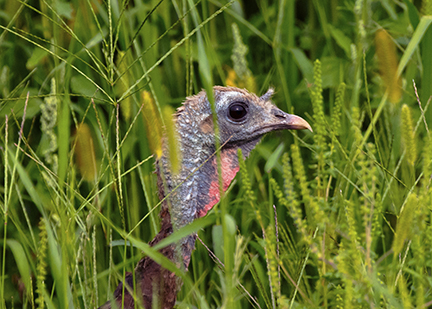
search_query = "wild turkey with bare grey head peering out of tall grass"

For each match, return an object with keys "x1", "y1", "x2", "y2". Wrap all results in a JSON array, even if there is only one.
[{"x1": 100, "y1": 86, "x2": 312, "y2": 309}]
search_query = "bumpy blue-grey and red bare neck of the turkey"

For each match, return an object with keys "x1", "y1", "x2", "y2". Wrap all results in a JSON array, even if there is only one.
[{"x1": 156, "y1": 103, "x2": 260, "y2": 269}]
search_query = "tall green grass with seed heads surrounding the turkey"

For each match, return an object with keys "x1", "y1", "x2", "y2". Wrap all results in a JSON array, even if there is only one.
[{"x1": 0, "y1": 0, "x2": 432, "y2": 308}]
